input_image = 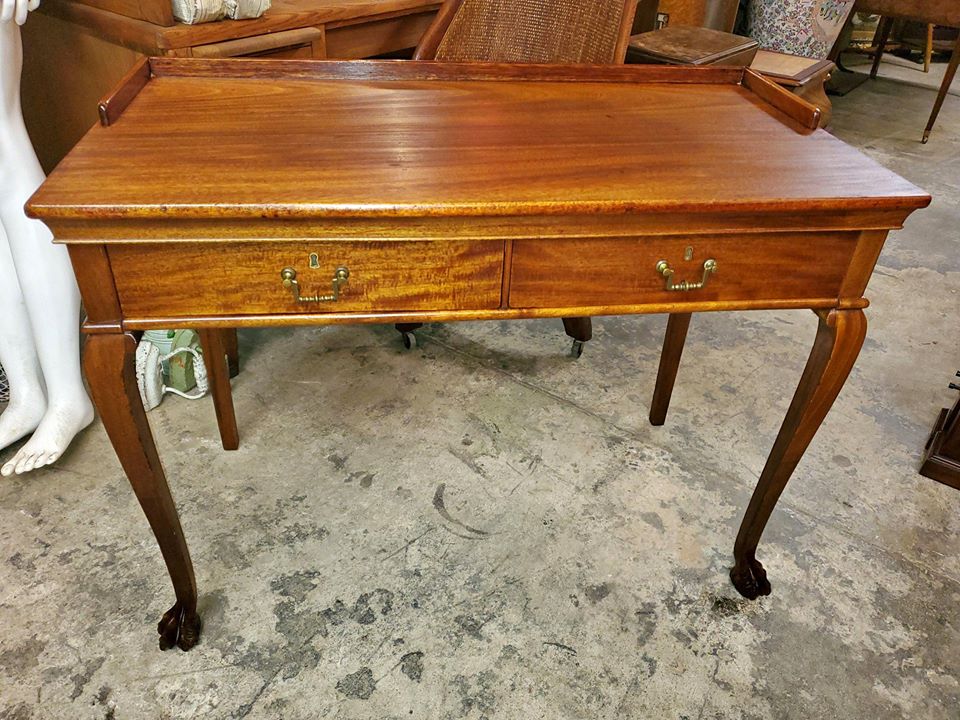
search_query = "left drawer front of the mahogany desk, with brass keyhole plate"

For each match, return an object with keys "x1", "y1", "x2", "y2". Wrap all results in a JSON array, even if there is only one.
[{"x1": 109, "y1": 240, "x2": 503, "y2": 319}]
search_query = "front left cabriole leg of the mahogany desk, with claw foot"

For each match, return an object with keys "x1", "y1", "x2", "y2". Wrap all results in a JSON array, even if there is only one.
[{"x1": 84, "y1": 333, "x2": 200, "y2": 650}]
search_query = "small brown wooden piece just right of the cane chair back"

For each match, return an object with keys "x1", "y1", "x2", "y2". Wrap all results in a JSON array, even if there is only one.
[{"x1": 627, "y1": 25, "x2": 759, "y2": 67}]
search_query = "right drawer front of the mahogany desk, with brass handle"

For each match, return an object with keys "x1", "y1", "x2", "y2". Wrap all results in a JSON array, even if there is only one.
[{"x1": 510, "y1": 232, "x2": 858, "y2": 308}]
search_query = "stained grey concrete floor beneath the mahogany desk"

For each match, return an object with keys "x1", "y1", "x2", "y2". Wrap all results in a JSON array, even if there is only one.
[{"x1": 0, "y1": 74, "x2": 960, "y2": 720}]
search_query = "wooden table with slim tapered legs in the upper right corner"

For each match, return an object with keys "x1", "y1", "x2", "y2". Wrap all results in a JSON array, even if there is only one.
[{"x1": 856, "y1": 0, "x2": 960, "y2": 143}]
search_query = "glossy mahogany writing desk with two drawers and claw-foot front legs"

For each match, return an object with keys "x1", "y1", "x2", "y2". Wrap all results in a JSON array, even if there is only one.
[{"x1": 28, "y1": 59, "x2": 930, "y2": 650}]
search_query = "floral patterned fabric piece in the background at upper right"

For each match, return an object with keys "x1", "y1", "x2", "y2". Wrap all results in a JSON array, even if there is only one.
[{"x1": 747, "y1": 0, "x2": 855, "y2": 60}]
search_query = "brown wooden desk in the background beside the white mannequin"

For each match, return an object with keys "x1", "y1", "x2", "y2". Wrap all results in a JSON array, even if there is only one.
[{"x1": 23, "y1": 0, "x2": 440, "y2": 172}]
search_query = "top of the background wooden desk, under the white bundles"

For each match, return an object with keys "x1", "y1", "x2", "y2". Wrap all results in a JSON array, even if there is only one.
[{"x1": 40, "y1": 0, "x2": 440, "y2": 55}]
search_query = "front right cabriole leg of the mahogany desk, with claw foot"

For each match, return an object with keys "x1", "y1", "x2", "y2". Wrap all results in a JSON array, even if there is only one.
[{"x1": 730, "y1": 310, "x2": 867, "y2": 600}]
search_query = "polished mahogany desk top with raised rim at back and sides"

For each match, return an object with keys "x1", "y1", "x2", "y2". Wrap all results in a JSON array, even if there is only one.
[{"x1": 30, "y1": 59, "x2": 929, "y2": 226}]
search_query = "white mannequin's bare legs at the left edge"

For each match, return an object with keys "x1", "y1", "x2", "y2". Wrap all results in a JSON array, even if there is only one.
[{"x1": 0, "y1": 21, "x2": 93, "y2": 475}]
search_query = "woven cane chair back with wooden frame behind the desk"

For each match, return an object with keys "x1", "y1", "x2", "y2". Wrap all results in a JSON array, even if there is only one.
[{"x1": 414, "y1": 0, "x2": 637, "y2": 64}]
